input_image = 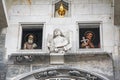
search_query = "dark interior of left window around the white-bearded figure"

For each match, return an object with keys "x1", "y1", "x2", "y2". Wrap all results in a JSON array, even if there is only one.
[{"x1": 21, "y1": 28, "x2": 43, "y2": 49}]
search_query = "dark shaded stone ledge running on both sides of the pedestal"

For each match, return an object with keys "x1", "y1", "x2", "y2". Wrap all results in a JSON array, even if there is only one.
[{"x1": 8, "y1": 52, "x2": 112, "y2": 64}]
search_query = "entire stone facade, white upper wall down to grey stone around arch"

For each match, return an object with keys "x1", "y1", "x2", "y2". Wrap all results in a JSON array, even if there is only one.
[{"x1": 0, "y1": 0, "x2": 119, "y2": 80}]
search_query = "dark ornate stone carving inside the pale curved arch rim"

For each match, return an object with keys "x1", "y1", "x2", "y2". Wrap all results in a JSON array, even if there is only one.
[{"x1": 33, "y1": 69, "x2": 103, "y2": 80}]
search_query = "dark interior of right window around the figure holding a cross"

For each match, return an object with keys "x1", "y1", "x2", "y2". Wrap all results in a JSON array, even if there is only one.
[{"x1": 79, "y1": 24, "x2": 100, "y2": 48}]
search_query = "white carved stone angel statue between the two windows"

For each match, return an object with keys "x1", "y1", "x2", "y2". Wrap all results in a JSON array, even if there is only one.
[{"x1": 47, "y1": 29, "x2": 72, "y2": 53}]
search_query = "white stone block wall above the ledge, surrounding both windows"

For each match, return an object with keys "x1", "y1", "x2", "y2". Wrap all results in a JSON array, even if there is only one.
[{"x1": 6, "y1": 0, "x2": 114, "y2": 55}]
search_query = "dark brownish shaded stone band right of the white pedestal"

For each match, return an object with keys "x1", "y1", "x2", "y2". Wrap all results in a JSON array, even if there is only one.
[{"x1": 65, "y1": 53, "x2": 112, "y2": 62}]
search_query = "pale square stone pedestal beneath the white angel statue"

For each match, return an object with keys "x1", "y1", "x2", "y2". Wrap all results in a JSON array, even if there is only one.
[{"x1": 50, "y1": 53, "x2": 64, "y2": 64}]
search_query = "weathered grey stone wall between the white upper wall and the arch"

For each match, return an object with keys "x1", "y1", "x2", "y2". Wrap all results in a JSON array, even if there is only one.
[{"x1": 7, "y1": 53, "x2": 114, "y2": 80}]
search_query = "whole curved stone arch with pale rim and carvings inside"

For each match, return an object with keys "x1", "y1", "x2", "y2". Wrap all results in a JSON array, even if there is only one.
[{"x1": 12, "y1": 67, "x2": 109, "y2": 80}]
